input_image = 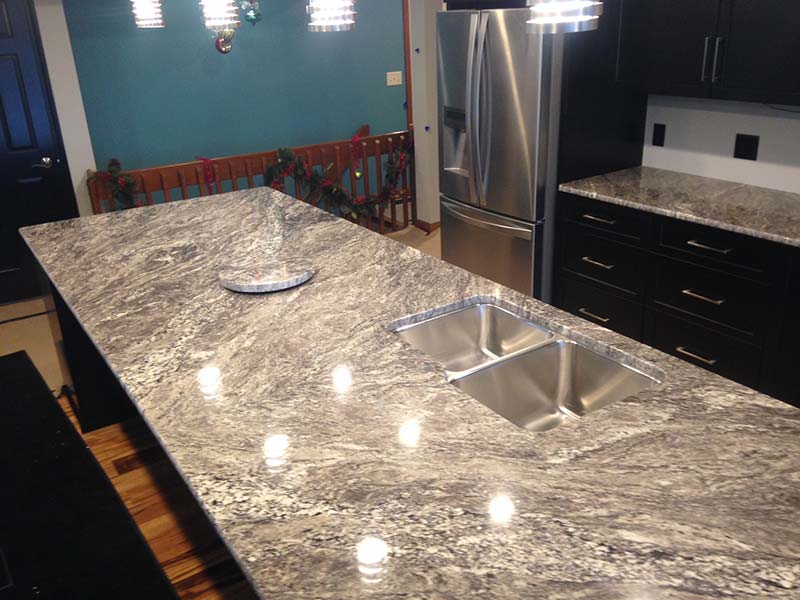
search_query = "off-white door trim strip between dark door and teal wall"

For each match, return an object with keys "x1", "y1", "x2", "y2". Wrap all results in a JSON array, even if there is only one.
[{"x1": 34, "y1": 0, "x2": 96, "y2": 216}]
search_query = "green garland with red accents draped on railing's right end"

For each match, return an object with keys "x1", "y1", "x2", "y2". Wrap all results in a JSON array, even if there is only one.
[{"x1": 264, "y1": 136, "x2": 414, "y2": 221}]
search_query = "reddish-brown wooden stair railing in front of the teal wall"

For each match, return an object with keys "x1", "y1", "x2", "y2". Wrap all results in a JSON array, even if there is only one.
[{"x1": 88, "y1": 125, "x2": 416, "y2": 233}]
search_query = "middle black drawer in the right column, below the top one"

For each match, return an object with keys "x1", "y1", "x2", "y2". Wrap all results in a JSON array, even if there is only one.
[{"x1": 652, "y1": 258, "x2": 769, "y2": 342}]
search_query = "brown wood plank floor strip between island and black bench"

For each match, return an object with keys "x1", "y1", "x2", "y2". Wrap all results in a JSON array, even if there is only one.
[{"x1": 58, "y1": 397, "x2": 256, "y2": 600}]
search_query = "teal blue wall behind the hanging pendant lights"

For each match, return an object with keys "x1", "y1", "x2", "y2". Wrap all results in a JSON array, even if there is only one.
[{"x1": 64, "y1": 0, "x2": 406, "y2": 169}]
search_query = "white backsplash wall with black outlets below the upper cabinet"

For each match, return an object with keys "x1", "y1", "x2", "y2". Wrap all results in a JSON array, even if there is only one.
[{"x1": 642, "y1": 96, "x2": 800, "y2": 192}]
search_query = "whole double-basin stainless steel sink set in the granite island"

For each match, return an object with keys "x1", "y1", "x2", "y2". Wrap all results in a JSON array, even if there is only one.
[{"x1": 391, "y1": 303, "x2": 659, "y2": 431}]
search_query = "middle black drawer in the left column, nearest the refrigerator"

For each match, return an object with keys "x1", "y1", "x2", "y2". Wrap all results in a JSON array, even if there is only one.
[{"x1": 562, "y1": 224, "x2": 645, "y2": 297}]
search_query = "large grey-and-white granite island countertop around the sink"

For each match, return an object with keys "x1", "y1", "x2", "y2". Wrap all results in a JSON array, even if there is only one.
[{"x1": 23, "y1": 188, "x2": 800, "y2": 600}]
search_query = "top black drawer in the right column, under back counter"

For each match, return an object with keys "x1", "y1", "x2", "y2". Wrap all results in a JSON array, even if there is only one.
[{"x1": 658, "y1": 219, "x2": 783, "y2": 281}]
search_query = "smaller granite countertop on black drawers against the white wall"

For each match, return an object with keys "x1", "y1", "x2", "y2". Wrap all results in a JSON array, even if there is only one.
[{"x1": 559, "y1": 167, "x2": 800, "y2": 246}]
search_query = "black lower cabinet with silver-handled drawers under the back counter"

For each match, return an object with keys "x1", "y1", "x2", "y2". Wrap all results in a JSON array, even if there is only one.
[{"x1": 555, "y1": 193, "x2": 800, "y2": 406}]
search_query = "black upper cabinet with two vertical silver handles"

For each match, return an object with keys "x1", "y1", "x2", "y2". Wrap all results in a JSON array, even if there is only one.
[{"x1": 621, "y1": 0, "x2": 800, "y2": 104}]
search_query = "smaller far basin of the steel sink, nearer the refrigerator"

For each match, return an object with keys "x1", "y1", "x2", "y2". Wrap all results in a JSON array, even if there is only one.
[{"x1": 395, "y1": 304, "x2": 554, "y2": 379}]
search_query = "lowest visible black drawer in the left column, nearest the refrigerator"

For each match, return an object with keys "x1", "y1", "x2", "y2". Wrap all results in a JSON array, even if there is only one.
[{"x1": 561, "y1": 274, "x2": 644, "y2": 340}]
